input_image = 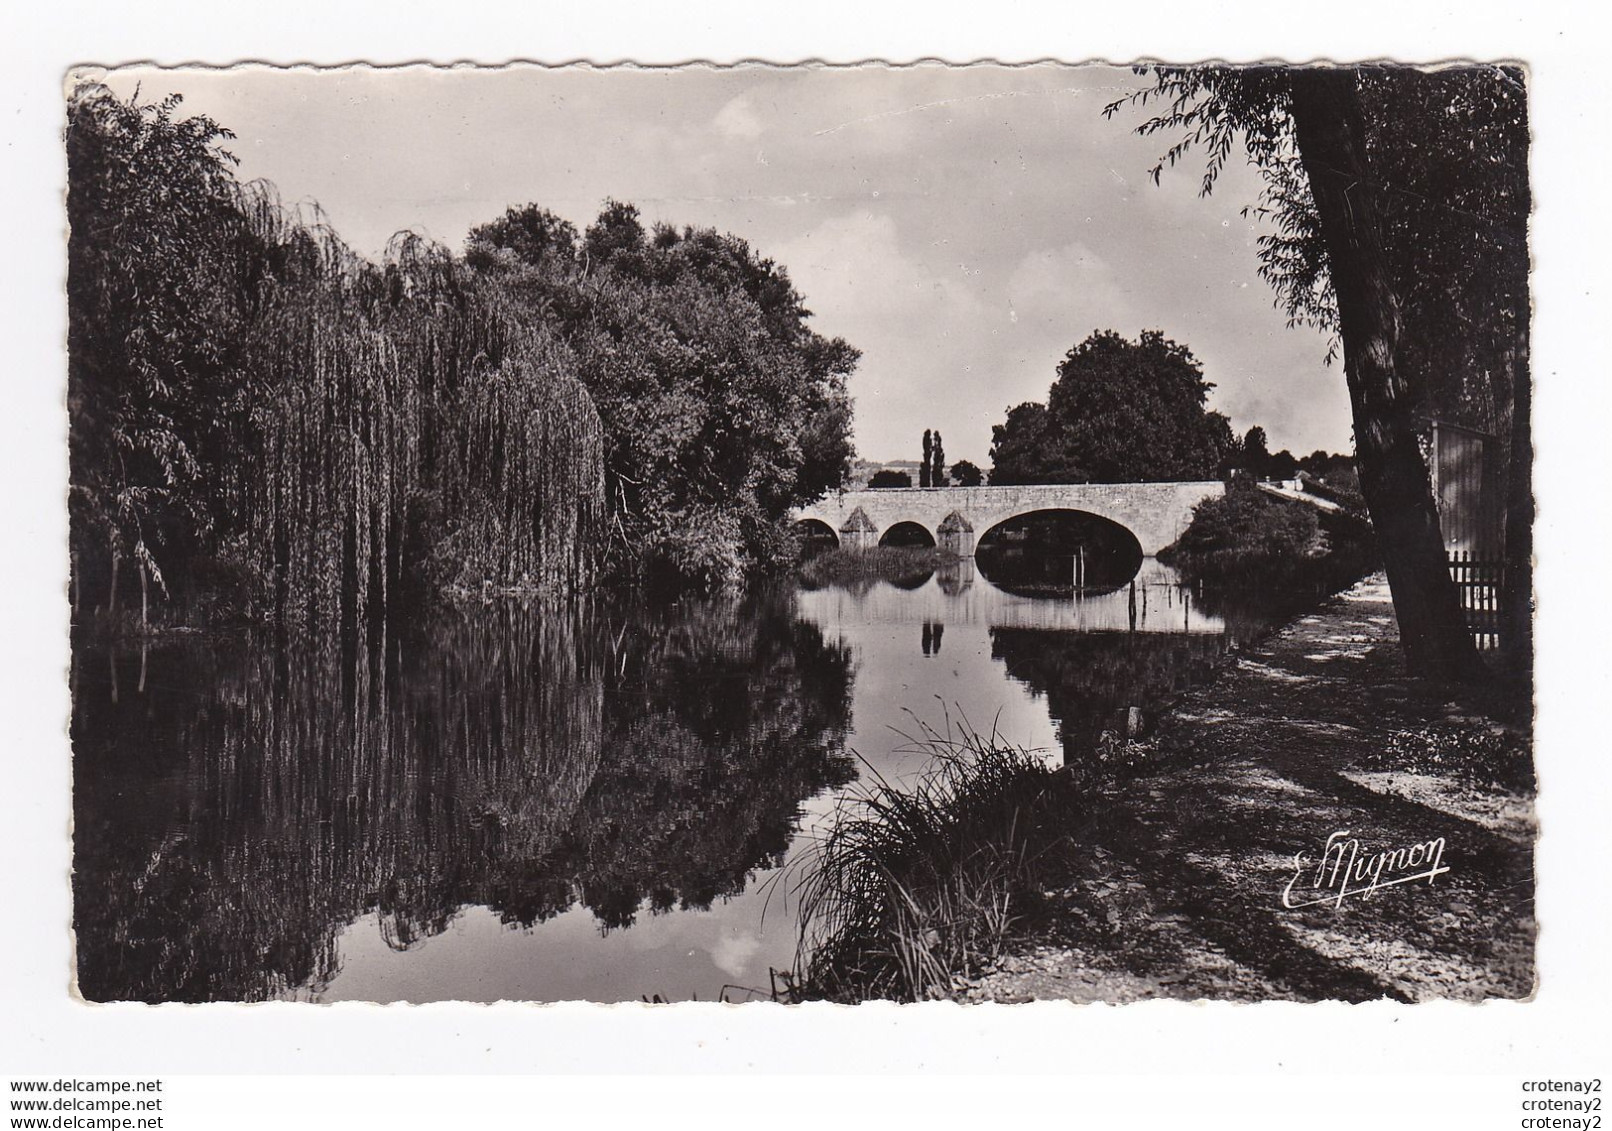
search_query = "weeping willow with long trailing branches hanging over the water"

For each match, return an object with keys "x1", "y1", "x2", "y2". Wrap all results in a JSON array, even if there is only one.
[{"x1": 240, "y1": 187, "x2": 603, "y2": 638}]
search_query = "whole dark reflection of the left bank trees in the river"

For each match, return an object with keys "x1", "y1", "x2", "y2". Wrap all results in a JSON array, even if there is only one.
[{"x1": 73, "y1": 598, "x2": 854, "y2": 1001}]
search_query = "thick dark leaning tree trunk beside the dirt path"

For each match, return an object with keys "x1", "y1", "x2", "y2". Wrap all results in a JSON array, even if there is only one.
[{"x1": 1291, "y1": 68, "x2": 1485, "y2": 680}]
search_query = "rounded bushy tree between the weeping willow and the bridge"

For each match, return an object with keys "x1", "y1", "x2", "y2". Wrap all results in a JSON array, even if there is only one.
[{"x1": 466, "y1": 201, "x2": 858, "y2": 586}]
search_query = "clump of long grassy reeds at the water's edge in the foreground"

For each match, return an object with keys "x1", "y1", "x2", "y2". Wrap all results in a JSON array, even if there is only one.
[{"x1": 787, "y1": 719, "x2": 1069, "y2": 1002}]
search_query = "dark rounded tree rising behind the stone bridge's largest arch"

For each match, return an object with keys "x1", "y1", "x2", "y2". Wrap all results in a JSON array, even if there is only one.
[{"x1": 991, "y1": 330, "x2": 1233, "y2": 483}]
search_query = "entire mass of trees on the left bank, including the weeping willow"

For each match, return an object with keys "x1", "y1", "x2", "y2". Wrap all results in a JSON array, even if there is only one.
[{"x1": 66, "y1": 85, "x2": 858, "y2": 632}]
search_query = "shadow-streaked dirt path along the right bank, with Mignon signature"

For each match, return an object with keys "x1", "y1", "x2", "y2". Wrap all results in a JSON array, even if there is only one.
[{"x1": 956, "y1": 575, "x2": 1535, "y2": 1002}]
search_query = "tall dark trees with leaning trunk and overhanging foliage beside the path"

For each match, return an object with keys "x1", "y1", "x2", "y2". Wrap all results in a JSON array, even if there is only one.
[{"x1": 1109, "y1": 66, "x2": 1531, "y2": 678}]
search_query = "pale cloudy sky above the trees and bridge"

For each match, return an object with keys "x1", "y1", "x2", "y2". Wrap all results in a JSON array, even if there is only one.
[{"x1": 97, "y1": 64, "x2": 1351, "y2": 466}]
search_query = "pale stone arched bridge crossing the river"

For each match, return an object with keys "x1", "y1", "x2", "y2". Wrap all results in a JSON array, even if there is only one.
[{"x1": 793, "y1": 482, "x2": 1225, "y2": 557}]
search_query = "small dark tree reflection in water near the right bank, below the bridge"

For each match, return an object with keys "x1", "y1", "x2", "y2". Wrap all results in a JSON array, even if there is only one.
[{"x1": 991, "y1": 628, "x2": 1225, "y2": 765}]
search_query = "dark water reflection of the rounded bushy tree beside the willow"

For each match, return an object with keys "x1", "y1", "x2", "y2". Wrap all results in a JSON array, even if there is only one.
[{"x1": 488, "y1": 601, "x2": 856, "y2": 928}]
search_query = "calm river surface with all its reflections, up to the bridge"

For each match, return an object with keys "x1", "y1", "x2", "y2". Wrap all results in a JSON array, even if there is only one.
[{"x1": 73, "y1": 559, "x2": 1283, "y2": 1002}]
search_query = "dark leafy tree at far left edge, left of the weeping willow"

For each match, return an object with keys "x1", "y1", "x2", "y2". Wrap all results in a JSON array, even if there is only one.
[{"x1": 68, "y1": 95, "x2": 245, "y2": 618}]
